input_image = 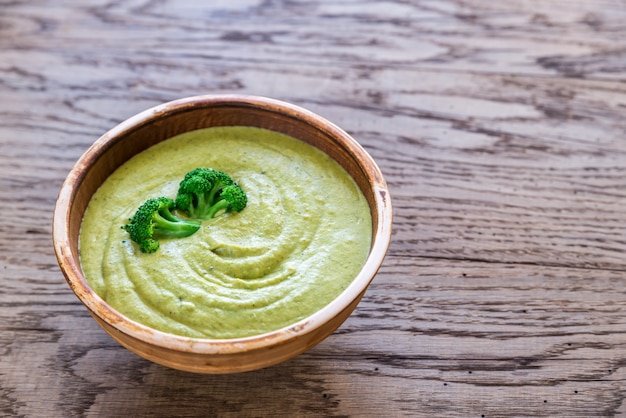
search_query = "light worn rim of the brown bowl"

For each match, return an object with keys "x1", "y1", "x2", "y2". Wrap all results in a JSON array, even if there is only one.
[{"x1": 52, "y1": 94, "x2": 392, "y2": 355}]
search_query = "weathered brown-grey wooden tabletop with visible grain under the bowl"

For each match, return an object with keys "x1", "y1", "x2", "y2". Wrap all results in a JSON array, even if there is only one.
[{"x1": 0, "y1": 0, "x2": 626, "y2": 417}]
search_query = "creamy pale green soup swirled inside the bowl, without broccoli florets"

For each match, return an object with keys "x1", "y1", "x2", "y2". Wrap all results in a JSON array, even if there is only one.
[{"x1": 80, "y1": 127, "x2": 372, "y2": 339}]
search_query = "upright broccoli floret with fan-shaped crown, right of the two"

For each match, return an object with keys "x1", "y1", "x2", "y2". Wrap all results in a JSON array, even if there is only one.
[{"x1": 176, "y1": 168, "x2": 248, "y2": 219}]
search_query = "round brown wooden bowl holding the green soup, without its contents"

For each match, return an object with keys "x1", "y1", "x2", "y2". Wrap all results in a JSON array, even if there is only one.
[{"x1": 53, "y1": 95, "x2": 392, "y2": 373}]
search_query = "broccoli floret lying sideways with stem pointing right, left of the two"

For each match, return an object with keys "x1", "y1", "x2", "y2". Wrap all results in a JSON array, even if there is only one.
[{"x1": 123, "y1": 197, "x2": 200, "y2": 253}]
